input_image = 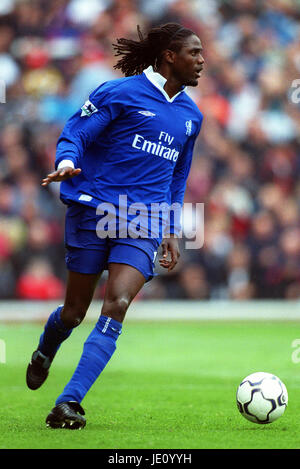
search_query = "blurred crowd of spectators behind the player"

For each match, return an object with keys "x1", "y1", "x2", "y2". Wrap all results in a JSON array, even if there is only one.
[{"x1": 0, "y1": 0, "x2": 300, "y2": 300}]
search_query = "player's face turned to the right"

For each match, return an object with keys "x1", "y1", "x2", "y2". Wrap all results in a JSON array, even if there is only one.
[{"x1": 172, "y1": 34, "x2": 204, "y2": 86}]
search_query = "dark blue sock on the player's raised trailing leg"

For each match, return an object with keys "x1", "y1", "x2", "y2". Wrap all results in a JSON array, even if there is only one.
[{"x1": 38, "y1": 306, "x2": 72, "y2": 360}]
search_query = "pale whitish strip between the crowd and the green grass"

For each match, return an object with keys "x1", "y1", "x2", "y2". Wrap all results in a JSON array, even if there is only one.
[{"x1": 0, "y1": 300, "x2": 300, "y2": 322}]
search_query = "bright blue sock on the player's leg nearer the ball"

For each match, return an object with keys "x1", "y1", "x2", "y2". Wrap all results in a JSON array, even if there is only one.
[{"x1": 55, "y1": 316, "x2": 122, "y2": 405}]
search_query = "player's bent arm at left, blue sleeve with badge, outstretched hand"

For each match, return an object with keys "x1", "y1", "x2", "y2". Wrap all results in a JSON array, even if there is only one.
[{"x1": 42, "y1": 80, "x2": 122, "y2": 186}]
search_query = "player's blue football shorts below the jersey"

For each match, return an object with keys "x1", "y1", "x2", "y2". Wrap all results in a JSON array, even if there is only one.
[{"x1": 65, "y1": 203, "x2": 159, "y2": 282}]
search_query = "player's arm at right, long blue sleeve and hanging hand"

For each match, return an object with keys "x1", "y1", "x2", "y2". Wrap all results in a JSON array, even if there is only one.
[{"x1": 159, "y1": 121, "x2": 202, "y2": 272}]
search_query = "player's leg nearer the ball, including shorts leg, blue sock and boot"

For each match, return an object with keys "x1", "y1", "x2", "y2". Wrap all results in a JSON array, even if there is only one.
[{"x1": 46, "y1": 240, "x2": 157, "y2": 428}]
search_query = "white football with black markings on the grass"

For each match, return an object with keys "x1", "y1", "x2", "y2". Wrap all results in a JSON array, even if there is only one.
[{"x1": 236, "y1": 372, "x2": 288, "y2": 424}]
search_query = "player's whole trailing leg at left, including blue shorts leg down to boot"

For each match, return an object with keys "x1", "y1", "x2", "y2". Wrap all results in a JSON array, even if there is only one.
[{"x1": 26, "y1": 204, "x2": 107, "y2": 389}]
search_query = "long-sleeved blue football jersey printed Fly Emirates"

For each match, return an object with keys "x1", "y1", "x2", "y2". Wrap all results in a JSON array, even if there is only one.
[{"x1": 55, "y1": 67, "x2": 203, "y2": 236}]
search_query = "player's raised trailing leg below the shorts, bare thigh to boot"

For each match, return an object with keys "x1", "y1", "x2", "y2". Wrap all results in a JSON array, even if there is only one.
[{"x1": 26, "y1": 271, "x2": 101, "y2": 390}]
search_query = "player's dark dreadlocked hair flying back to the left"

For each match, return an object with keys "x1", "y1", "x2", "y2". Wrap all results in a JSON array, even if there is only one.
[{"x1": 112, "y1": 23, "x2": 195, "y2": 77}]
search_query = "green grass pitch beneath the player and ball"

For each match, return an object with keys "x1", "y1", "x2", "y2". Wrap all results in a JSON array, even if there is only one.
[{"x1": 0, "y1": 320, "x2": 300, "y2": 449}]
